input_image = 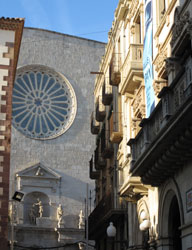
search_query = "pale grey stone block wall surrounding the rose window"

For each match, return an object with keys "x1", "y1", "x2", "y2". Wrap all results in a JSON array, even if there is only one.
[{"x1": 10, "y1": 28, "x2": 105, "y2": 248}]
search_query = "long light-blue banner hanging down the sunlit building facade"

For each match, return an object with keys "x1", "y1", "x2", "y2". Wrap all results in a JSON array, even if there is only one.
[{"x1": 143, "y1": 0, "x2": 155, "y2": 117}]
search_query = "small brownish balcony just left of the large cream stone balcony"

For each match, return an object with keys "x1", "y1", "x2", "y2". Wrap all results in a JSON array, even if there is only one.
[{"x1": 109, "y1": 53, "x2": 121, "y2": 86}]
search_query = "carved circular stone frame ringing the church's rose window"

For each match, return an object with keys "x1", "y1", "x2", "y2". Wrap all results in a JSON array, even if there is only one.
[{"x1": 12, "y1": 64, "x2": 77, "y2": 140}]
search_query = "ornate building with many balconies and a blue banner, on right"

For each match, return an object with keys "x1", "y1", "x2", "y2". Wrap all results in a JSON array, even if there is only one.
[{"x1": 89, "y1": 0, "x2": 192, "y2": 250}]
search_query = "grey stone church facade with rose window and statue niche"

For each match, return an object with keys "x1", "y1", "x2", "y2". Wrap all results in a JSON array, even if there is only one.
[{"x1": 10, "y1": 28, "x2": 105, "y2": 249}]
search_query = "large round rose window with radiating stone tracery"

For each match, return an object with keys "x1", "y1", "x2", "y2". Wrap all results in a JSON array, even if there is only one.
[{"x1": 12, "y1": 65, "x2": 76, "y2": 139}]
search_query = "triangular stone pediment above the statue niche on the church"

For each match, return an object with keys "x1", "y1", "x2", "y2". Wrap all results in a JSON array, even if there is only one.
[{"x1": 16, "y1": 163, "x2": 61, "y2": 180}]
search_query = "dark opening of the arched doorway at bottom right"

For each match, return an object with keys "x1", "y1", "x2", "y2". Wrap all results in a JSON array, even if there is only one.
[{"x1": 168, "y1": 195, "x2": 182, "y2": 250}]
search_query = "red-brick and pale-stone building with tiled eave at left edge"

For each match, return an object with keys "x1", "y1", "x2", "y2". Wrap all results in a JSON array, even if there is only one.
[{"x1": 0, "y1": 18, "x2": 23, "y2": 250}]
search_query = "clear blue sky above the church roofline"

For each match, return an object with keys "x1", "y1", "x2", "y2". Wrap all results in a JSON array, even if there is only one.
[{"x1": 0, "y1": 0, "x2": 119, "y2": 42}]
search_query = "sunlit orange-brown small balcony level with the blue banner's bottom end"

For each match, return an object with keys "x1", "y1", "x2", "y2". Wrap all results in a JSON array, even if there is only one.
[{"x1": 109, "y1": 112, "x2": 123, "y2": 143}]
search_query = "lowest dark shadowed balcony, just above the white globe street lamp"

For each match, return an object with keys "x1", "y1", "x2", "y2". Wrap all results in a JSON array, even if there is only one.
[{"x1": 88, "y1": 193, "x2": 125, "y2": 239}]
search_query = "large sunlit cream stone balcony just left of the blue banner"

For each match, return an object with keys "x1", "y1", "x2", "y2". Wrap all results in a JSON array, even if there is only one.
[{"x1": 119, "y1": 44, "x2": 143, "y2": 94}]
